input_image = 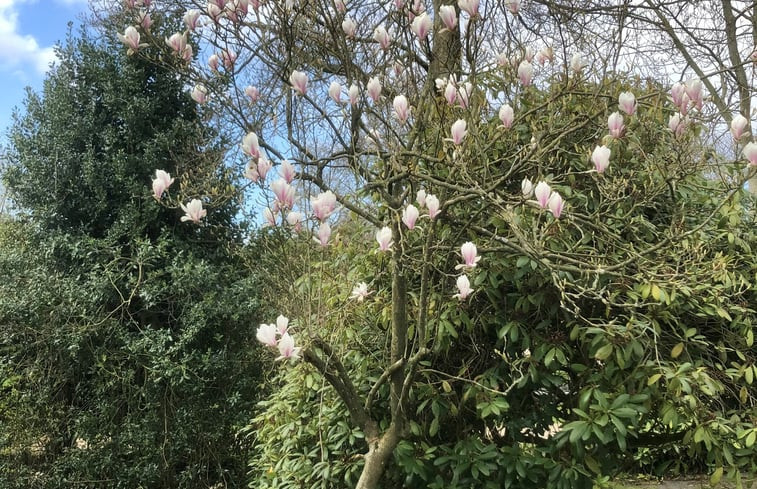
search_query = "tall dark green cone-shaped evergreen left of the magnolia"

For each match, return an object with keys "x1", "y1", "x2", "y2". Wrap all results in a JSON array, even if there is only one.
[{"x1": 0, "y1": 27, "x2": 261, "y2": 489}]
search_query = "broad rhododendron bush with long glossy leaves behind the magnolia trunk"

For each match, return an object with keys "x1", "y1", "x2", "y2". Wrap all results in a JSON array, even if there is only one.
[{"x1": 250, "y1": 80, "x2": 757, "y2": 489}]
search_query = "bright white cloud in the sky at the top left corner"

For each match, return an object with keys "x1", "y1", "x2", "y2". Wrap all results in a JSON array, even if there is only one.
[{"x1": 0, "y1": 0, "x2": 56, "y2": 74}]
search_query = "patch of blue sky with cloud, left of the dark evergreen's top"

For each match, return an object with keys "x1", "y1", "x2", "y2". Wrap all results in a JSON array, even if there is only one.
[{"x1": 0, "y1": 0, "x2": 87, "y2": 135}]
